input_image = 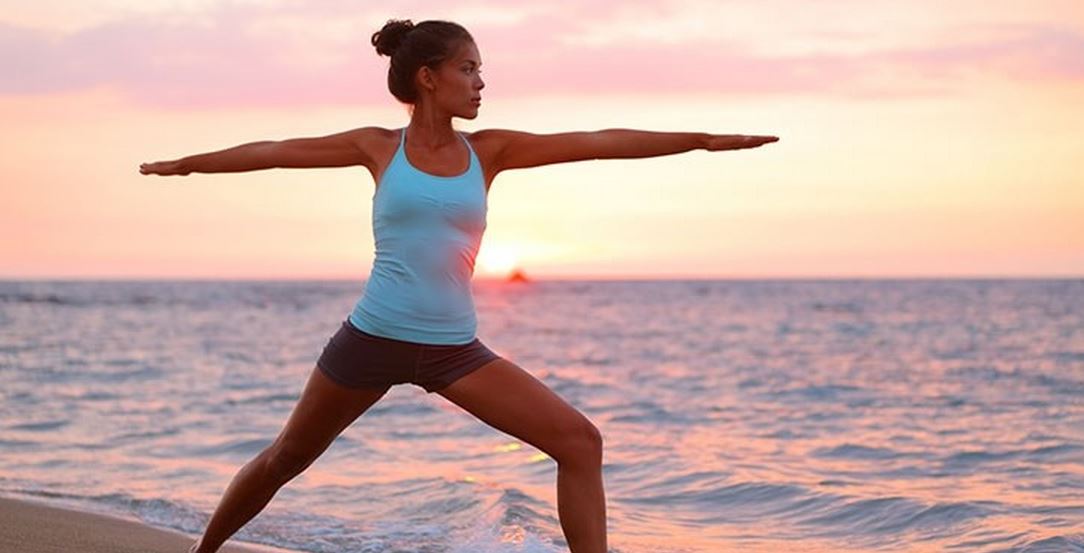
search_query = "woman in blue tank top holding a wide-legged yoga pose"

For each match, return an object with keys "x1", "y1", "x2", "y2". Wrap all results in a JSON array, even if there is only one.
[{"x1": 140, "y1": 20, "x2": 778, "y2": 553}]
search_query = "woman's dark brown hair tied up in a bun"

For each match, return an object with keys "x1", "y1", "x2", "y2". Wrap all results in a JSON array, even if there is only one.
[{"x1": 372, "y1": 20, "x2": 474, "y2": 104}]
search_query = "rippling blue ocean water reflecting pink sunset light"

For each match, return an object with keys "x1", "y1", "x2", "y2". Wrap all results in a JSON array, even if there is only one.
[{"x1": 0, "y1": 279, "x2": 1084, "y2": 553}]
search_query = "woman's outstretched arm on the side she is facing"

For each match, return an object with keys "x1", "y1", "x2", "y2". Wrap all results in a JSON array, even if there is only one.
[{"x1": 475, "y1": 129, "x2": 779, "y2": 171}]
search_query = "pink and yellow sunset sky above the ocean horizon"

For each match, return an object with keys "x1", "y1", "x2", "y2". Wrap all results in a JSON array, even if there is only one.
[{"x1": 0, "y1": 0, "x2": 1084, "y2": 279}]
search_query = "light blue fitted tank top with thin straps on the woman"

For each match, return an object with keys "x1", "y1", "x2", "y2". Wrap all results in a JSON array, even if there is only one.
[{"x1": 349, "y1": 129, "x2": 487, "y2": 345}]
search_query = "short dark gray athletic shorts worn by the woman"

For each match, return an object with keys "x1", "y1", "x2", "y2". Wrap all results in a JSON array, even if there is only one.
[{"x1": 317, "y1": 319, "x2": 500, "y2": 394}]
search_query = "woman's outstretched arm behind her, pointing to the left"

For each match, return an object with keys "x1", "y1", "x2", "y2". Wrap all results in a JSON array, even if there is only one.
[{"x1": 140, "y1": 127, "x2": 383, "y2": 175}]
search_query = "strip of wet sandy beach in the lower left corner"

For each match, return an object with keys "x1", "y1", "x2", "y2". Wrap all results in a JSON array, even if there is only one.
[{"x1": 0, "y1": 498, "x2": 299, "y2": 553}]
